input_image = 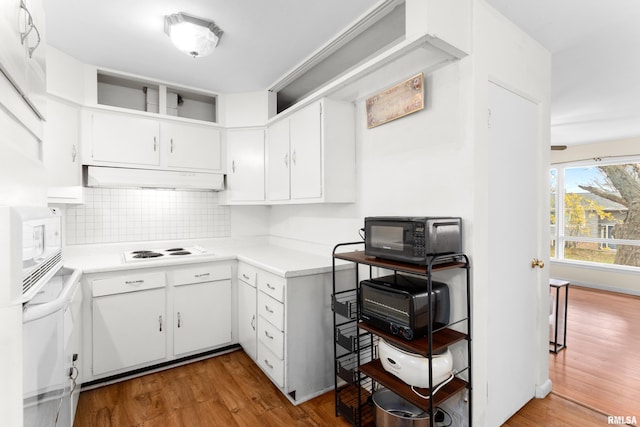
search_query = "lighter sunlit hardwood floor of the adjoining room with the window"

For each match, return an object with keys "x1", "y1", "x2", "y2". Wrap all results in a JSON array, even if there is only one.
[{"x1": 549, "y1": 286, "x2": 640, "y2": 420}]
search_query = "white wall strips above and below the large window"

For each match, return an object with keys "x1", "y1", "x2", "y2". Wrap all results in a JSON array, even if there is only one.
[{"x1": 551, "y1": 137, "x2": 640, "y2": 295}]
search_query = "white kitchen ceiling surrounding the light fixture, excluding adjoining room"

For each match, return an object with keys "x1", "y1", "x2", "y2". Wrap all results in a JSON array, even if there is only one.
[{"x1": 44, "y1": 0, "x2": 380, "y2": 93}]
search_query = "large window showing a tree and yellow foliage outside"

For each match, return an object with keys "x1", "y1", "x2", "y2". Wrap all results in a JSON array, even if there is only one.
[{"x1": 549, "y1": 157, "x2": 640, "y2": 267}]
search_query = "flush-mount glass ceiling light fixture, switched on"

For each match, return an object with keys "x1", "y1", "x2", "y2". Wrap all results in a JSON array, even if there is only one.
[{"x1": 164, "y1": 12, "x2": 224, "y2": 58}]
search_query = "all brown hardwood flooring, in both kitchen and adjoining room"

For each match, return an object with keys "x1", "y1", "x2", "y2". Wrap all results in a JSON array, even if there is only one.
[{"x1": 74, "y1": 286, "x2": 640, "y2": 427}]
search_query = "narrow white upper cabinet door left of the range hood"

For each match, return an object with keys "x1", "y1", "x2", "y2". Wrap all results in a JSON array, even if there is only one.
[{"x1": 42, "y1": 98, "x2": 82, "y2": 203}]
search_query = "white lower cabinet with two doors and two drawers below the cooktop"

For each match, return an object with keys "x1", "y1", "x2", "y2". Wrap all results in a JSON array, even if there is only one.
[{"x1": 83, "y1": 262, "x2": 234, "y2": 382}]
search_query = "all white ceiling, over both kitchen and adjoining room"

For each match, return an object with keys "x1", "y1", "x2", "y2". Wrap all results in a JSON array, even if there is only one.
[{"x1": 44, "y1": 0, "x2": 640, "y2": 145}]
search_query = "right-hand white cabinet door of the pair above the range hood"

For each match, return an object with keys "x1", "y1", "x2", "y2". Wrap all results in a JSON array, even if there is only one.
[{"x1": 160, "y1": 122, "x2": 222, "y2": 172}]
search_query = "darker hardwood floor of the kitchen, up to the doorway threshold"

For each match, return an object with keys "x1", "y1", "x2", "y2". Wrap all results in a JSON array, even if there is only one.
[{"x1": 74, "y1": 351, "x2": 607, "y2": 427}]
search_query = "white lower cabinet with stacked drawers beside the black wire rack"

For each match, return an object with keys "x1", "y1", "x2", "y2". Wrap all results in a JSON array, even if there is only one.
[{"x1": 238, "y1": 262, "x2": 344, "y2": 404}]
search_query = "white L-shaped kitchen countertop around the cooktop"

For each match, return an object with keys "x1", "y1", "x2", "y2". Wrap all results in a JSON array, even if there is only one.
[{"x1": 63, "y1": 237, "x2": 349, "y2": 277}]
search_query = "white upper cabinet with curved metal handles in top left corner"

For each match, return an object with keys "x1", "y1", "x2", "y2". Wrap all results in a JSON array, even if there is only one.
[{"x1": 0, "y1": 0, "x2": 46, "y2": 118}]
